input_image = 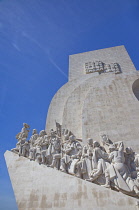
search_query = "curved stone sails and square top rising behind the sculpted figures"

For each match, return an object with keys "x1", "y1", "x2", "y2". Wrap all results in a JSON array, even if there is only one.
[{"x1": 46, "y1": 46, "x2": 139, "y2": 152}]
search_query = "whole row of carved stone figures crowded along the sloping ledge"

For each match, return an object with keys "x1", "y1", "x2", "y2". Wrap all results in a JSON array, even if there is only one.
[{"x1": 12, "y1": 123, "x2": 139, "y2": 197}]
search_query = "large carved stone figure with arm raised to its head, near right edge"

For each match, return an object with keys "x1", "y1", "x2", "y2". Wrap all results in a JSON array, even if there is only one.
[{"x1": 105, "y1": 141, "x2": 139, "y2": 195}]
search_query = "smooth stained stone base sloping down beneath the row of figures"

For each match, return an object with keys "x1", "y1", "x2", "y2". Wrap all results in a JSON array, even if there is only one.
[{"x1": 5, "y1": 151, "x2": 139, "y2": 210}]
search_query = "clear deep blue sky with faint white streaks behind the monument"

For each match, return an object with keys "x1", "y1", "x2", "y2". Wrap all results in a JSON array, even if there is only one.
[{"x1": 0, "y1": 0, "x2": 139, "y2": 210}]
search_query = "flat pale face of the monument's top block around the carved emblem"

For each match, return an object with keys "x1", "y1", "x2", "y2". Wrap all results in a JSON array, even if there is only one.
[{"x1": 69, "y1": 46, "x2": 136, "y2": 81}]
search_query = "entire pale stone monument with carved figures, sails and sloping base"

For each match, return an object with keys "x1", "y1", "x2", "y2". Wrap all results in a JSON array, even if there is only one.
[{"x1": 5, "y1": 46, "x2": 139, "y2": 210}]
